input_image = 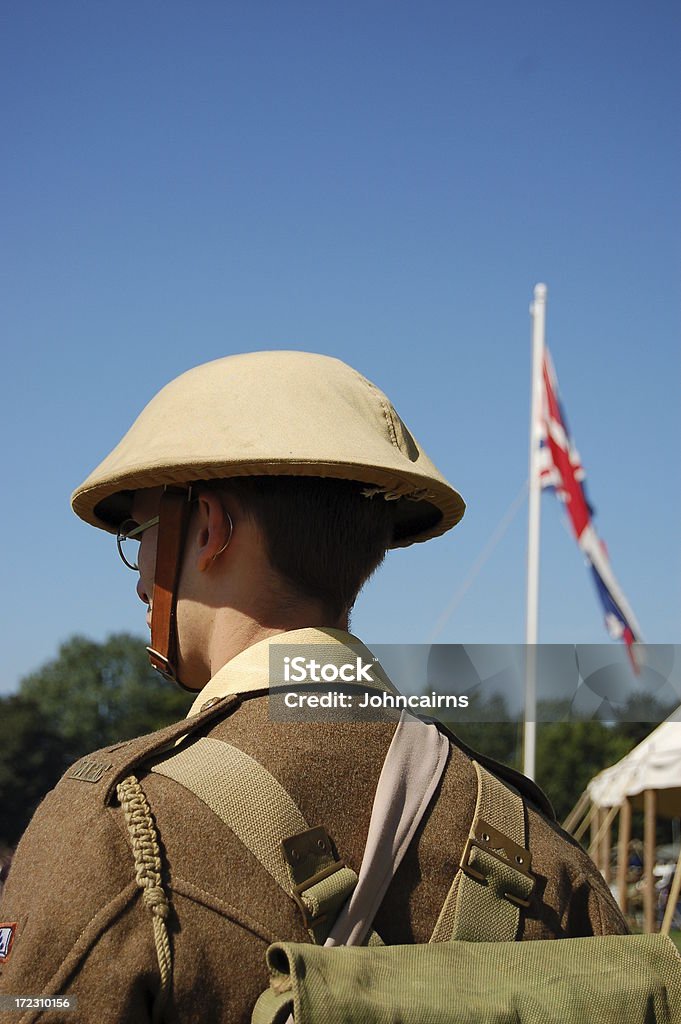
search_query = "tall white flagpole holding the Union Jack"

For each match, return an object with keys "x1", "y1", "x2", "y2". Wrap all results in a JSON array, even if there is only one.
[{"x1": 522, "y1": 285, "x2": 547, "y2": 779}]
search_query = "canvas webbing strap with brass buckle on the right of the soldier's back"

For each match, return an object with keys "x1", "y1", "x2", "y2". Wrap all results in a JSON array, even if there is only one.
[{"x1": 430, "y1": 761, "x2": 535, "y2": 942}]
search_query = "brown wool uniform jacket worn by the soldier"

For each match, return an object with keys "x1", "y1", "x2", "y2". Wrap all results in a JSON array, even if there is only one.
[{"x1": 0, "y1": 634, "x2": 627, "y2": 1024}]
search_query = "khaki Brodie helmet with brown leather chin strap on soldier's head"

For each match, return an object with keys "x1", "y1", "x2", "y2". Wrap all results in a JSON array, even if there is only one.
[{"x1": 72, "y1": 351, "x2": 465, "y2": 678}]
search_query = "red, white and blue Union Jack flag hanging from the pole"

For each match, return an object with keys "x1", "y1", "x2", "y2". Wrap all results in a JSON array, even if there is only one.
[{"x1": 536, "y1": 349, "x2": 641, "y2": 669}]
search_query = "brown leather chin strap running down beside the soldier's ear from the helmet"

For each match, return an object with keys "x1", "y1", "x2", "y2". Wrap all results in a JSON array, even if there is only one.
[{"x1": 146, "y1": 487, "x2": 191, "y2": 690}]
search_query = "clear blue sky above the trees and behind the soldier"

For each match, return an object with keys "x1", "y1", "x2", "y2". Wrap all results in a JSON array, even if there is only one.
[{"x1": 0, "y1": 0, "x2": 681, "y2": 691}]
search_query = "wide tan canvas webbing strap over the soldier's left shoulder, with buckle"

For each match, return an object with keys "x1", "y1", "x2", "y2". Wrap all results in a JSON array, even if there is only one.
[{"x1": 151, "y1": 736, "x2": 357, "y2": 942}]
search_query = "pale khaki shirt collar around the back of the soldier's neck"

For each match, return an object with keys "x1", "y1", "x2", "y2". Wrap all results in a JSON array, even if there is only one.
[{"x1": 186, "y1": 628, "x2": 395, "y2": 718}]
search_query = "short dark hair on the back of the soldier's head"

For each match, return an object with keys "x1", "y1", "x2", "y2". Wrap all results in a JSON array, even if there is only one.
[{"x1": 213, "y1": 476, "x2": 393, "y2": 620}]
